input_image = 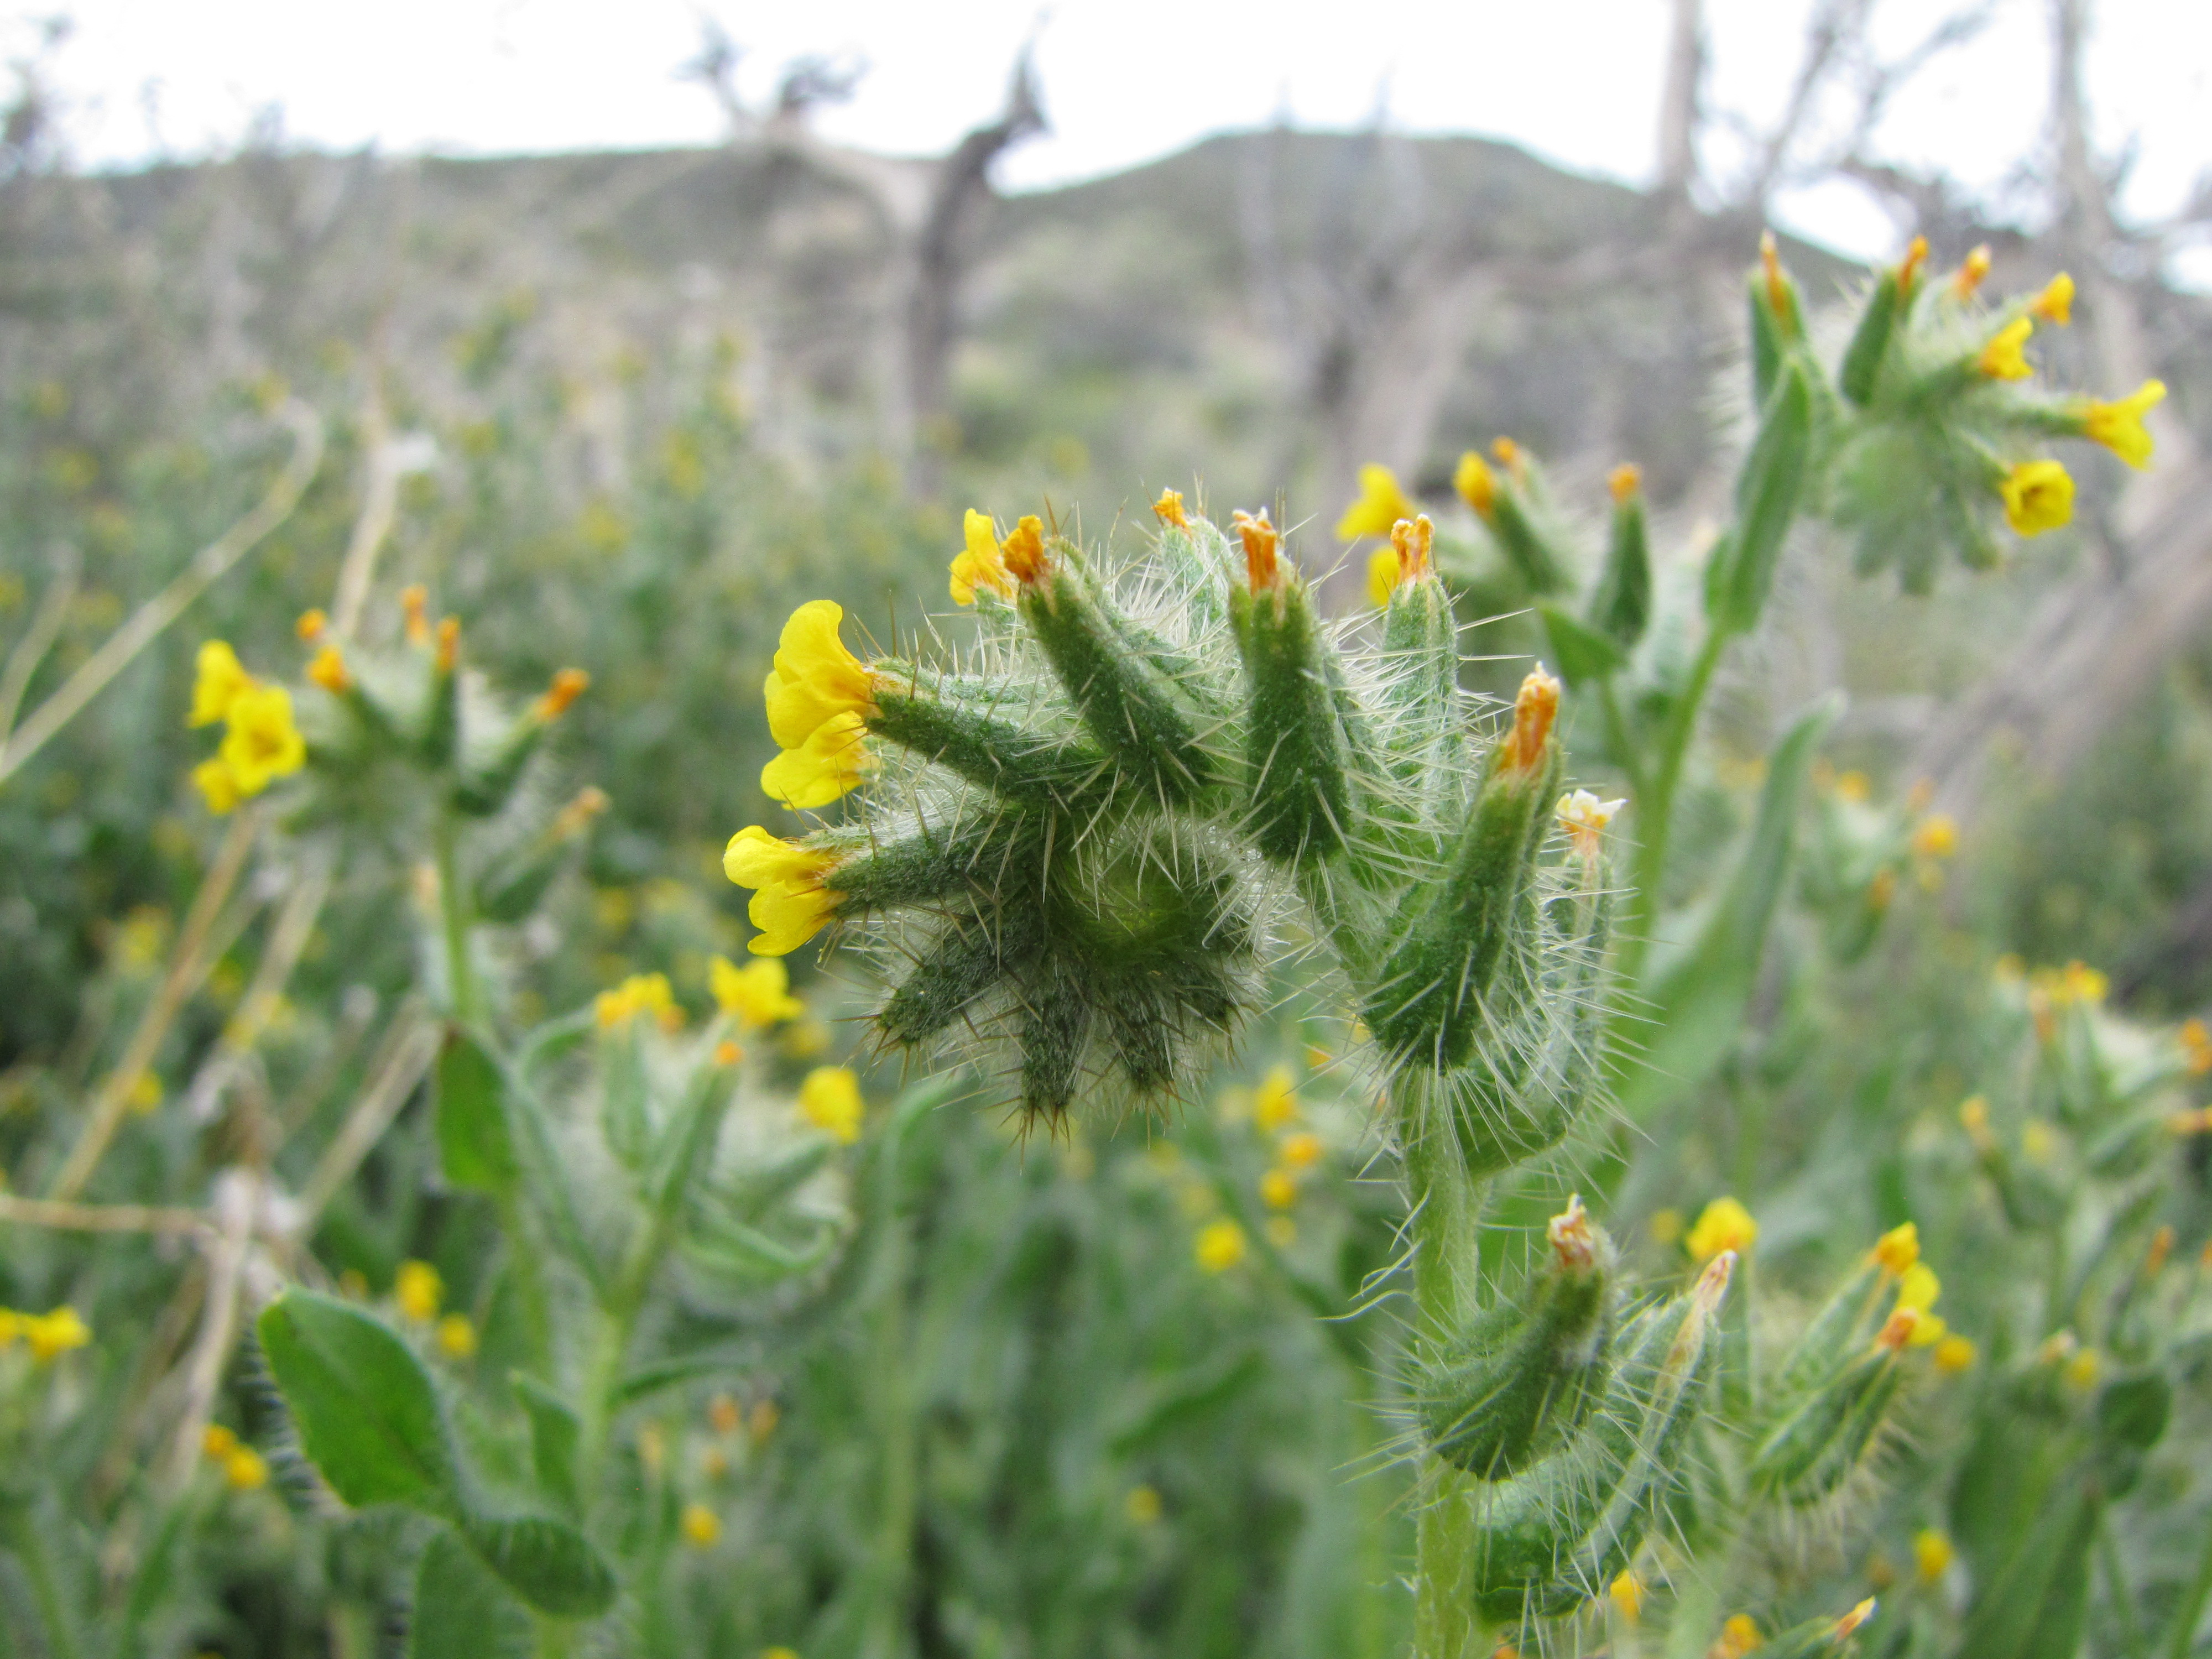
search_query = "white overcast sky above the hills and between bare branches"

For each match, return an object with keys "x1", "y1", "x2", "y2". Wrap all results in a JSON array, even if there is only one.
[{"x1": 0, "y1": 0, "x2": 2212, "y2": 274}]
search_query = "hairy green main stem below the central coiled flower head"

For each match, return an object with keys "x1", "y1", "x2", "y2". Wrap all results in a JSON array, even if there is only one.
[{"x1": 1398, "y1": 1084, "x2": 1489, "y2": 1659}]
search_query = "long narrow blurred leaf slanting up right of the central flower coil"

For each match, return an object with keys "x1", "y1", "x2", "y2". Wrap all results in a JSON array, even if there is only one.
[{"x1": 1619, "y1": 699, "x2": 1838, "y2": 1113}]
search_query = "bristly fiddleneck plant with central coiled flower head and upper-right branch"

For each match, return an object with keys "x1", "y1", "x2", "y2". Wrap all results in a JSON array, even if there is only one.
[{"x1": 723, "y1": 243, "x2": 2159, "y2": 1659}]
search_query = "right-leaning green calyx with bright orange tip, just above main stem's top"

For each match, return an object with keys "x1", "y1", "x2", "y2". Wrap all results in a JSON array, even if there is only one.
[{"x1": 1367, "y1": 739, "x2": 1559, "y2": 1068}]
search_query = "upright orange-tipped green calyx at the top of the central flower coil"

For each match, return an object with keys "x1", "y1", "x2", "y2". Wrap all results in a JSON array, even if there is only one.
[{"x1": 1230, "y1": 571, "x2": 1352, "y2": 865}]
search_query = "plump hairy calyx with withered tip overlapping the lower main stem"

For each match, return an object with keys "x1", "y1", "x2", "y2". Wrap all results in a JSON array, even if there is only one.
[{"x1": 1413, "y1": 1212, "x2": 1613, "y2": 1480}]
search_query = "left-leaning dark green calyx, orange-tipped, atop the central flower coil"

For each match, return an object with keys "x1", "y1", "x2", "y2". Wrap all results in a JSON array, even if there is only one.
[{"x1": 1020, "y1": 555, "x2": 1214, "y2": 805}]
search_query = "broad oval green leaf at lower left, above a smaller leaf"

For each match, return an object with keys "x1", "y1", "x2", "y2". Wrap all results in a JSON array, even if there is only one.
[{"x1": 257, "y1": 1290, "x2": 460, "y2": 1515}]
